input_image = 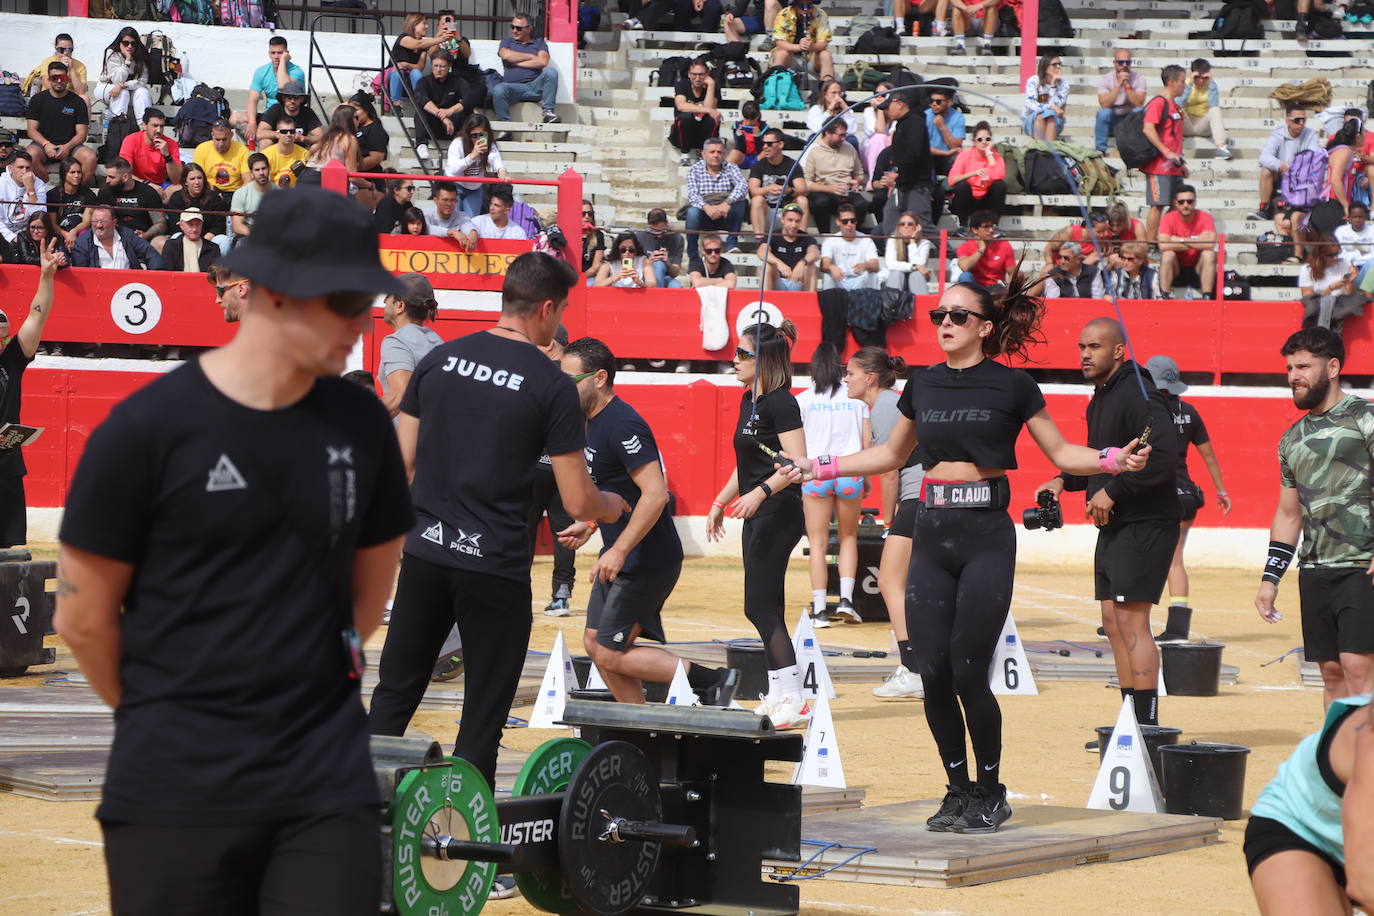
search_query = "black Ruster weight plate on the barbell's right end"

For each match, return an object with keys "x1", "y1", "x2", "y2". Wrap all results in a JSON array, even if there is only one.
[{"x1": 558, "y1": 742, "x2": 664, "y2": 916}]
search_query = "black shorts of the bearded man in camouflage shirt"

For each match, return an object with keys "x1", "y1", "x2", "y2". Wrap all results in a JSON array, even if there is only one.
[{"x1": 1297, "y1": 566, "x2": 1374, "y2": 662}]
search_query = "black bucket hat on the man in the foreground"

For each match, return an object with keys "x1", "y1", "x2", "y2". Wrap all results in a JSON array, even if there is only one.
[{"x1": 220, "y1": 187, "x2": 405, "y2": 298}]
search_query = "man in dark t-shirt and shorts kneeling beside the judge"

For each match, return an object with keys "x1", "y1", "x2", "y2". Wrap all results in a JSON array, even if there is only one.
[{"x1": 559, "y1": 338, "x2": 739, "y2": 706}]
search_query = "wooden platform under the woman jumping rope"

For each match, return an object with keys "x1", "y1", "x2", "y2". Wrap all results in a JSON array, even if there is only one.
[{"x1": 764, "y1": 799, "x2": 1221, "y2": 887}]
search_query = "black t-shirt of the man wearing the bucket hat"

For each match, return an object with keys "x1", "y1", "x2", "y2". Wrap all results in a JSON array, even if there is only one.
[{"x1": 60, "y1": 361, "x2": 414, "y2": 827}]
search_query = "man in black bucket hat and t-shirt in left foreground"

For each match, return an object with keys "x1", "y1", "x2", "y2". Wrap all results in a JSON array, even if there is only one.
[{"x1": 55, "y1": 188, "x2": 414, "y2": 916}]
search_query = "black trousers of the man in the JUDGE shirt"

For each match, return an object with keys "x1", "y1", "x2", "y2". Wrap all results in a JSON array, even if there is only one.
[{"x1": 368, "y1": 553, "x2": 532, "y2": 788}]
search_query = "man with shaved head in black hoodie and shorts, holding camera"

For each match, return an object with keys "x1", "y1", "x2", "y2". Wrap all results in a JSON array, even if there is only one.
[{"x1": 1040, "y1": 319, "x2": 1183, "y2": 725}]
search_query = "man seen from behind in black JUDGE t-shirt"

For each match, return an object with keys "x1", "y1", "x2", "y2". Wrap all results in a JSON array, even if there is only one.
[{"x1": 370, "y1": 251, "x2": 627, "y2": 783}]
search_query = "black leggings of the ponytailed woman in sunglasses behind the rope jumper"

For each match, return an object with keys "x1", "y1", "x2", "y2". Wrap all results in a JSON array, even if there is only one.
[{"x1": 741, "y1": 500, "x2": 807, "y2": 672}]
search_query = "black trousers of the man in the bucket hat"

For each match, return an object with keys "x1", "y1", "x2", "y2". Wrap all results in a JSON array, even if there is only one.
[{"x1": 100, "y1": 805, "x2": 382, "y2": 916}]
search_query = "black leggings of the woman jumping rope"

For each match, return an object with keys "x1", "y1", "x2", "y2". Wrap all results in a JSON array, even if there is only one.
[{"x1": 907, "y1": 503, "x2": 1017, "y2": 786}]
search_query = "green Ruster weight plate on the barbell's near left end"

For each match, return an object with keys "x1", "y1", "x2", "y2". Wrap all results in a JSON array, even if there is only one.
[{"x1": 392, "y1": 758, "x2": 500, "y2": 916}]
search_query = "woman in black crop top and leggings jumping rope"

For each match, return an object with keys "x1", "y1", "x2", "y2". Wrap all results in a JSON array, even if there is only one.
[{"x1": 789, "y1": 273, "x2": 1149, "y2": 834}]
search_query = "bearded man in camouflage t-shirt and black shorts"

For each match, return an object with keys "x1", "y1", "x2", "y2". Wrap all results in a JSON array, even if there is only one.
[{"x1": 1254, "y1": 328, "x2": 1374, "y2": 706}]
